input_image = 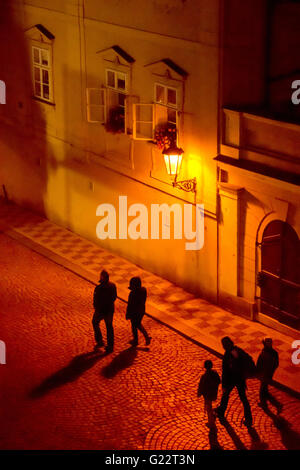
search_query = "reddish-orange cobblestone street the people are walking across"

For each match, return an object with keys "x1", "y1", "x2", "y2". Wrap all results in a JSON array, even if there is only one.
[{"x1": 0, "y1": 234, "x2": 300, "y2": 450}]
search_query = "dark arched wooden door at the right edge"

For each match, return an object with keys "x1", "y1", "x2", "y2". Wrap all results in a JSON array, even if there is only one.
[{"x1": 257, "y1": 220, "x2": 300, "y2": 330}]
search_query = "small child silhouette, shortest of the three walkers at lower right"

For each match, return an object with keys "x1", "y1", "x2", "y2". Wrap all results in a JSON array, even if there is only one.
[{"x1": 198, "y1": 360, "x2": 221, "y2": 429}]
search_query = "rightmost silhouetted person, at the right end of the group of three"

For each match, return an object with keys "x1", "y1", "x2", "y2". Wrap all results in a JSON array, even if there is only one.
[{"x1": 256, "y1": 338, "x2": 282, "y2": 413}]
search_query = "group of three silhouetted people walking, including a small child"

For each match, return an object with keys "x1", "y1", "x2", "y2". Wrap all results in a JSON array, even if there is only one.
[{"x1": 198, "y1": 336, "x2": 282, "y2": 428}]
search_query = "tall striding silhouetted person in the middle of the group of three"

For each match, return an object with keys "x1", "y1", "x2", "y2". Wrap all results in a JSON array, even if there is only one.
[{"x1": 216, "y1": 336, "x2": 253, "y2": 427}]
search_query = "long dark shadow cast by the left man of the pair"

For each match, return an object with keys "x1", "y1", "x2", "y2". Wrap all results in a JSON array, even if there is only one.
[{"x1": 29, "y1": 351, "x2": 107, "y2": 399}]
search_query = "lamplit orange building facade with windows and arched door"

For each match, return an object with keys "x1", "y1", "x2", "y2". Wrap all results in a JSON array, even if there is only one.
[{"x1": 0, "y1": 0, "x2": 300, "y2": 336}]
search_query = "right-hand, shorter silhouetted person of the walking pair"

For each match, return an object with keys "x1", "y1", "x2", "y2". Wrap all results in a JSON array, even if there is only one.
[{"x1": 126, "y1": 277, "x2": 151, "y2": 346}]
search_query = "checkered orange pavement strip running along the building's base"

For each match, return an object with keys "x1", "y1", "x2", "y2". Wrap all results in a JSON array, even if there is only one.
[{"x1": 0, "y1": 196, "x2": 300, "y2": 393}]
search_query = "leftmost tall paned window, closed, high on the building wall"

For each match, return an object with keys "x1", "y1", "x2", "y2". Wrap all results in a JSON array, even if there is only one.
[{"x1": 32, "y1": 46, "x2": 53, "y2": 102}]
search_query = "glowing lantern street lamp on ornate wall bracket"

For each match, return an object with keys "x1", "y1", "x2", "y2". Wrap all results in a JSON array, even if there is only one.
[{"x1": 162, "y1": 145, "x2": 197, "y2": 193}]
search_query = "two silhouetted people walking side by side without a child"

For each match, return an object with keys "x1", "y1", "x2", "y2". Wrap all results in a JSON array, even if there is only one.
[{"x1": 92, "y1": 270, "x2": 151, "y2": 353}]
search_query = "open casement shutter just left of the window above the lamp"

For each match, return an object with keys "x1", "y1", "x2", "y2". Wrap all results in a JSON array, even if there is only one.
[{"x1": 132, "y1": 103, "x2": 154, "y2": 140}]
